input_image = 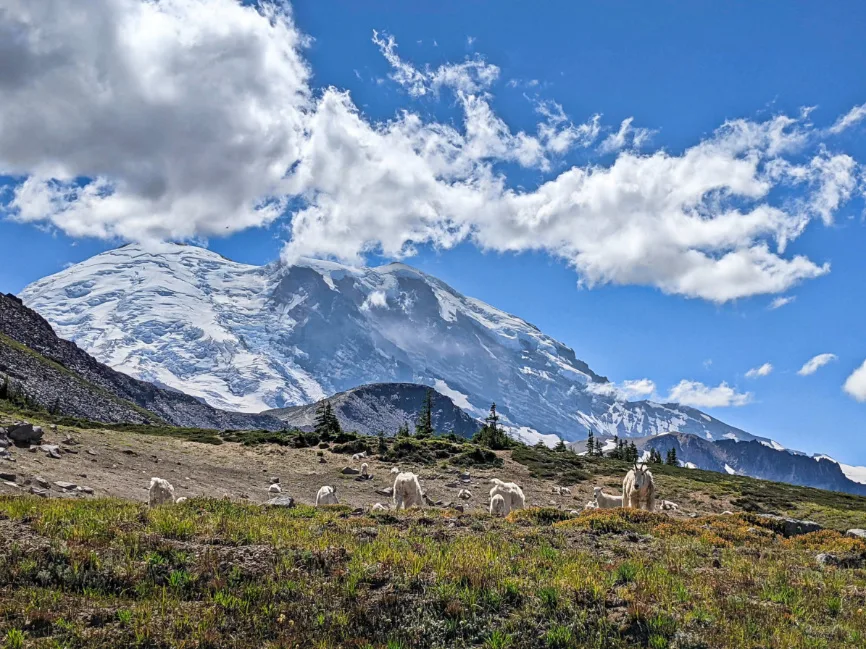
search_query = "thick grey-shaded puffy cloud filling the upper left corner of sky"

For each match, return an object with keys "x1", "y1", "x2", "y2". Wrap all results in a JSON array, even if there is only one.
[{"x1": 0, "y1": 0, "x2": 310, "y2": 239}]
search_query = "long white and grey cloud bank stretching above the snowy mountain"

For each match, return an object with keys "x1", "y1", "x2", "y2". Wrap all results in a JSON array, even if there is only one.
[{"x1": 0, "y1": 0, "x2": 862, "y2": 303}]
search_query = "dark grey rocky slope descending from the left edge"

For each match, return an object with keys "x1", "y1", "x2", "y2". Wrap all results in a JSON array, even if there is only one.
[{"x1": 0, "y1": 294, "x2": 282, "y2": 430}]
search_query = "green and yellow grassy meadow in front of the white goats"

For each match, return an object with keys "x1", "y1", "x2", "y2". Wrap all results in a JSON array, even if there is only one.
[{"x1": 0, "y1": 497, "x2": 866, "y2": 649}]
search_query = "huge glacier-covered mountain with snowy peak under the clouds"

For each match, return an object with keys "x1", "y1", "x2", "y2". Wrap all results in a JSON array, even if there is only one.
[{"x1": 21, "y1": 244, "x2": 754, "y2": 440}]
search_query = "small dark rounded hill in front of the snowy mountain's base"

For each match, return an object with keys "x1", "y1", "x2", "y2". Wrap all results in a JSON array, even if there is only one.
[{"x1": 263, "y1": 383, "x2": 481, "y2": 437}]
